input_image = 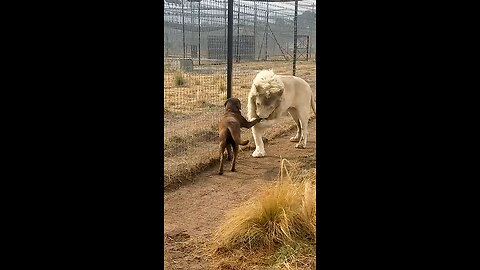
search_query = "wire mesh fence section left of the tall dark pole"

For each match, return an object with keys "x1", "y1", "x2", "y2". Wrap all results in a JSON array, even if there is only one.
[{"x1": 164, "y1": 0, "x2": 227, "y2": 185}]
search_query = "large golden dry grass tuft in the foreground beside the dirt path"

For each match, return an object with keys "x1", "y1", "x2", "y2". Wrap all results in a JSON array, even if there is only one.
[{"x1": 210, "y1": 160, "x2": 316, "y2": 269}]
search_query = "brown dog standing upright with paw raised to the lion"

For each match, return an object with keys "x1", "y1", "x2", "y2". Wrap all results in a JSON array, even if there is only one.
[{"x1": 218, "y1": 98, "x2": 262, "y2": 175}]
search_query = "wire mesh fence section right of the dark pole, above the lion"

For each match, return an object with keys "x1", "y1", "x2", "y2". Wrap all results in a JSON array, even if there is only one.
[{"x1": 232, "y1": 0, "x2": 316, "y2": 110}]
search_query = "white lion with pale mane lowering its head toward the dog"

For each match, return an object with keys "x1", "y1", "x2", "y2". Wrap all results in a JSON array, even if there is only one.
[{"x1": 248, "y1": 70, "x2": 317, "y2": 157}]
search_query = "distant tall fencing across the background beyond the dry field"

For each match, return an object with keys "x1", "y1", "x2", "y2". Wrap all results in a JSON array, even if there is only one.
[{"x1": 164, "y1": 0, "x2": 316, "y2": 64}]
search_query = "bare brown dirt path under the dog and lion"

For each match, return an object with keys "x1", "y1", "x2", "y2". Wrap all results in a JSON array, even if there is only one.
[{"x1": 164, "y1": 120, "x2": 317, "y2": 270}]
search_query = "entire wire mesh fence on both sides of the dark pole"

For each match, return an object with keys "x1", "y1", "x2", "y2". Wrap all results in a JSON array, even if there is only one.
[{"x1": 164, "y1": 0, "x2": 316, "y2": 186}]
